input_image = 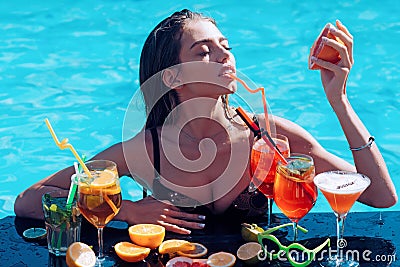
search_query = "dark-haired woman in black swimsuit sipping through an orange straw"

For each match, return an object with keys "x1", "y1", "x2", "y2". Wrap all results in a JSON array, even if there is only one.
[{"x1": 15, "y1": 10, "x2": 397, "y2": 234}]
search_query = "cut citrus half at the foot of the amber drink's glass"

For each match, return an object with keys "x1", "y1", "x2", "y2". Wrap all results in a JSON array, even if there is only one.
[{"x1": 66, "y1": 242, "x2": 96, "y2": 267}]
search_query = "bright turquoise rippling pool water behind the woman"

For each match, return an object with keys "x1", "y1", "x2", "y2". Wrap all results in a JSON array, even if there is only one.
[{"x1": 0, "y1": 0, "x2": 400, "y2": 218}]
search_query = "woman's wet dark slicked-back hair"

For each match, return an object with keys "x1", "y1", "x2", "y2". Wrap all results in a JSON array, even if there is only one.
[{"x1": 139, "y1": 9, "x2": 216, "y2": 129}]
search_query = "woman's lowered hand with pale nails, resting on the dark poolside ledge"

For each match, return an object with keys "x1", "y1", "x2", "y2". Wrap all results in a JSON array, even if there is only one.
[{"x1": 116, "y1": 196, "x2": 205, "y2": 234}]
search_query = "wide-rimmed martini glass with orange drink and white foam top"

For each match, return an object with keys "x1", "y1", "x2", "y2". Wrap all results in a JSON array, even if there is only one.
[{"x1": 314, "y1": 171, "x2": 371, "y2": 267}]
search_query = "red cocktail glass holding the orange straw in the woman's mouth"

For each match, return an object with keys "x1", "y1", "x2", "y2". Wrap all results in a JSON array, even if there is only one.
[{"x1": 249, "y1": 134, "x2": 290, "y2": 225}]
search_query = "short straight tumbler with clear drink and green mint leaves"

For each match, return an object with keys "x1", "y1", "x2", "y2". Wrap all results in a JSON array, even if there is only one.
[{"x1": 42, "y1": 190, "x2": 81, "y2": 256}]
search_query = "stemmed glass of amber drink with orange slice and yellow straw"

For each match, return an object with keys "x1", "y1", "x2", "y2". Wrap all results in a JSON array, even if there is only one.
[{"x1": 78, "y1": 160, "x2": 122, "y2": 266}]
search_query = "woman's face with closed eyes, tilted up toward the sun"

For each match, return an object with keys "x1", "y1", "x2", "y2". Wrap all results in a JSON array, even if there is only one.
[{"x1": 179, "y1": 20, "x2": 236, "y2": 97}]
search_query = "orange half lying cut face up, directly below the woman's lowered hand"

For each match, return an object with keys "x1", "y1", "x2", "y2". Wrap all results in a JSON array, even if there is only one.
[{"x1": 128, "y1": 224, "x2": 165, "y2": 249}]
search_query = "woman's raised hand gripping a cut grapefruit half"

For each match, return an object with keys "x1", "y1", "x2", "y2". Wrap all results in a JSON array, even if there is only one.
[{"x1": 311, "y1": 20, "x2": 354, "y2": 107}]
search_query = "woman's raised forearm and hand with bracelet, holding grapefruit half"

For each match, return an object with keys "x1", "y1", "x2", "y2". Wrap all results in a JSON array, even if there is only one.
[{"x1": 312, "y1": 21, "x2": 397, "y2": 207}]
